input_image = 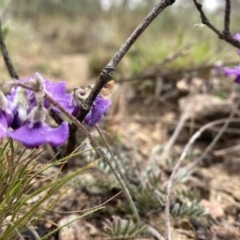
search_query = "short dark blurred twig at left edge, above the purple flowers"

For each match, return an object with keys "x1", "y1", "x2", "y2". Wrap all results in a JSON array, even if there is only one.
[{"x1": 0, "y1": 19, "x2": 18, "y2": 79}]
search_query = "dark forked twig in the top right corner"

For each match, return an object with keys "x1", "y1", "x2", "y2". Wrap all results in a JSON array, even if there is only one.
[{"x1": 193, "y1": 0, "x2": 240, "y2": 49}]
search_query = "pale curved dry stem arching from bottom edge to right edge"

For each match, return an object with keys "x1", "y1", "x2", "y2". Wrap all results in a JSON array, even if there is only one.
[{"x1": 165, "y1": 118, "x2": 240, "y2": 240}]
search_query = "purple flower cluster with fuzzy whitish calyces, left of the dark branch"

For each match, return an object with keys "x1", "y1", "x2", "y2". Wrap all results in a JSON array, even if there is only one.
[{"x1": 3, "y1": 73, "x2": 75, "y2": 148}]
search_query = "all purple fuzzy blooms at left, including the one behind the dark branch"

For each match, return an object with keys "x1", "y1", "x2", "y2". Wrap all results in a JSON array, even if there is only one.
[{"x1": 0, "y1": 73, "x2": 111, "y2": 148}]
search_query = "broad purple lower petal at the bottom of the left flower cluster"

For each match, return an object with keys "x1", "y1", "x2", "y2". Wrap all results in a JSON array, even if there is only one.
[{"x1": 8, "y1": 122, "x2": 69, "y2": 148}]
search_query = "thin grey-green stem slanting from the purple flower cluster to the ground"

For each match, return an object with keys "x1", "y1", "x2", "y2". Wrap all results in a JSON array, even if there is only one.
[{"x1": 45, "y1": 93, "x2": 141, "y2": 223}]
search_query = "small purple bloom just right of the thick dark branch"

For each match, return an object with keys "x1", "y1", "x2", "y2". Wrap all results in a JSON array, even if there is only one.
[{"x1": 84, "y1": 96, "x2": 112, "y2": 127}]
